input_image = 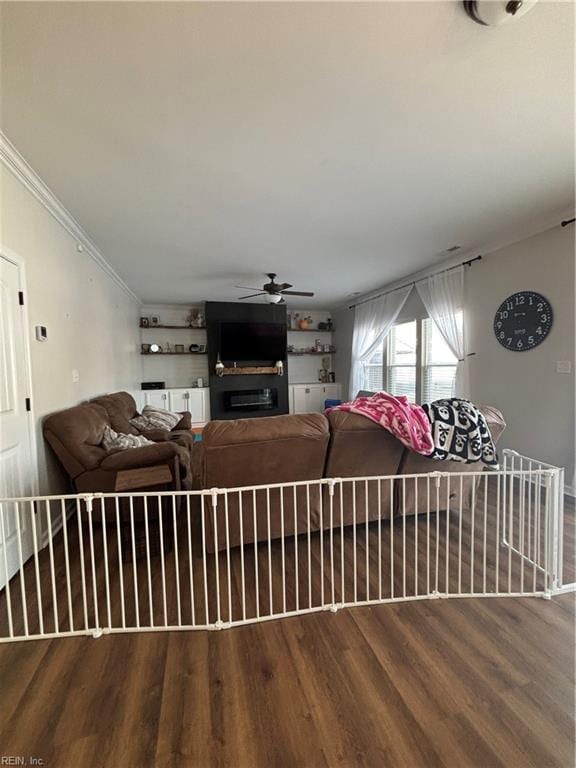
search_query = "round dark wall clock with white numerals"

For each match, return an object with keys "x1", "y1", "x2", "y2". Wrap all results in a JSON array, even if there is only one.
[{"x1": 494, "y1": 291, "x2": 553, "y2": 352}]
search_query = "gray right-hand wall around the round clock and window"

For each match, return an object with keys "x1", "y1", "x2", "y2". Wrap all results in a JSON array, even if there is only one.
[{"x1": 332, "y1": 226, "x2": 576, "y2": 489}]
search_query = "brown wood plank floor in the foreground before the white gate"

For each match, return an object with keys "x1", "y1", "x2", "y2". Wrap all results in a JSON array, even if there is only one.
[{"x1": 0, "y1": 492, "x2": 575, "y2": 768}]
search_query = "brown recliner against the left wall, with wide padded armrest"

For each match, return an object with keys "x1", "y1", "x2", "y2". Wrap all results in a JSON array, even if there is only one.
[{"x1": 43, "y1": 403, "x2": 190, "y2": 493}]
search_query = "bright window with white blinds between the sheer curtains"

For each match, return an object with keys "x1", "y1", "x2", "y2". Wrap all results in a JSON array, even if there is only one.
[{"x1": 364, "y1": 316, "x2": 461, "y2": 403}]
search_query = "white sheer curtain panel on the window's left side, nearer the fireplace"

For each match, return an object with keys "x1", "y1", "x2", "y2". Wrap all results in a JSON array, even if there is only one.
[{"x1": 349, "y1": 285, "x2": 412, "y2": 398}]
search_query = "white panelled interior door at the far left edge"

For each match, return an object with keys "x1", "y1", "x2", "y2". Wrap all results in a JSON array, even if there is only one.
[{"x1": 0, "y1": 254, "x2": 34, "y2": 588}]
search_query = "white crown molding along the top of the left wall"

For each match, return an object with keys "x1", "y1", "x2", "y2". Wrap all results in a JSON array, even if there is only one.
[{"x1": 0, "y1": 131, "x2": 142, "y2": 304}]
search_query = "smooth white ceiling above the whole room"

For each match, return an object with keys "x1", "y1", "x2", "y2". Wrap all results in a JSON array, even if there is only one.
[{"x1": 1, "y1": 2, "x2": 574, "y2": 306}]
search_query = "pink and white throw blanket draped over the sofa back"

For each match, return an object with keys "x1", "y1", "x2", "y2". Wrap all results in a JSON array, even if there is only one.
[{"x1": 326, "y1": 392, "x2": 434, "y2": 456}]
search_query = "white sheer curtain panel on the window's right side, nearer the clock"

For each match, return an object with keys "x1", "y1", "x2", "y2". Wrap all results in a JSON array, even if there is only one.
[{"x1": 416, "y1": 266, "x2": 469, "y2": 397}]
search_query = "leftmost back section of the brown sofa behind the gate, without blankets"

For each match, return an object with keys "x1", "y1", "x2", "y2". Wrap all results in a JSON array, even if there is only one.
[{"x1": 202, "y1": 413, "x2": 329, "y2": 552}]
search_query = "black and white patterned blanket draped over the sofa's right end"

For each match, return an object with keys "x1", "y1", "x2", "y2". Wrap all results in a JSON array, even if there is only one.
[{"x1": 422, "y1": 398, "x2": 498, "y2": 467}]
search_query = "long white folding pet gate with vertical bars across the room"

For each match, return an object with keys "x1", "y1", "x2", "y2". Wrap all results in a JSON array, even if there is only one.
[{"x1": 0, "y1": 451, "x2": 576, "y2": 642}]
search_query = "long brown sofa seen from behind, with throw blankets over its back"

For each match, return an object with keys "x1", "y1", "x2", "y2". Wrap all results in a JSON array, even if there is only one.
[{"x1": 201, "y1": 407, "x2": 506, "y2": 551}]
